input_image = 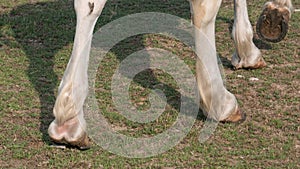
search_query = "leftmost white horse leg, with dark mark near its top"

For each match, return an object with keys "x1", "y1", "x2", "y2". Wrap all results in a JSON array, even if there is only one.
[{"x1": 48, "y1": 0, "x2": 106, "y2": 148}]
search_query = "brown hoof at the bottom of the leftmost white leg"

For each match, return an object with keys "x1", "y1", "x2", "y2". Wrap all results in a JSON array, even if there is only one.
[{"x1": 50, "y1": 133, "x2": 91, "y2": 150}]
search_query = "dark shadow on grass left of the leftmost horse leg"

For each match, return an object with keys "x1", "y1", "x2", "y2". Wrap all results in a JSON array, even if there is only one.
[{"x1": 1, "y1": 1, "x2": 75, "y2": 143}]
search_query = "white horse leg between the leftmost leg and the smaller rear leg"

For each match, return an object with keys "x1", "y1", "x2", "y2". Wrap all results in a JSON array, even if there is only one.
[{"x1": 190, "y1": 0, "x2": 244, "y2": 122}]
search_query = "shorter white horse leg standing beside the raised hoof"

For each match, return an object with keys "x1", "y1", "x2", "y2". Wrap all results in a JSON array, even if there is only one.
[{"x1": 231, "y1": 0, "x2": 266, "y2": 69}]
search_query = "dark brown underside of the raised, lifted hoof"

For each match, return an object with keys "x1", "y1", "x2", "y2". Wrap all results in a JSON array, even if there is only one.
[{"x1": 256, "y1": 4, "x2": 290, "y2": 43}]
